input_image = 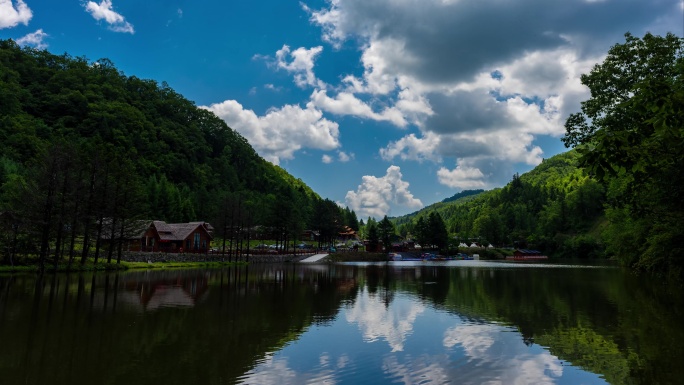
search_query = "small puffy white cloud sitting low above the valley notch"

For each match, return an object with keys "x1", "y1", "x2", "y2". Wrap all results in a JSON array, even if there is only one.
[{"x1": 345, "y1": 165, "x2": 423, "y2": 218}]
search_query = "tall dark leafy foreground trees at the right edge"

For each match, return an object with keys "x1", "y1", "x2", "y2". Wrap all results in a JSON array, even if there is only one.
[{"x1": 563, "y1": 34, "x2": 684, "y2": 278}]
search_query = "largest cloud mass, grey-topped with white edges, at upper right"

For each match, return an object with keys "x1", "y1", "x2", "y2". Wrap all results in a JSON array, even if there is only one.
[{"x1": 304, "y1": 0, "x2": 681, "y2": 188}]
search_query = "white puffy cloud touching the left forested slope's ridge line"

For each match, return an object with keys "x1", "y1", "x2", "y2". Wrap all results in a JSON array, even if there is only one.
[{"x1": 201, "y1": 100, "x2": 340, "y2": 164}]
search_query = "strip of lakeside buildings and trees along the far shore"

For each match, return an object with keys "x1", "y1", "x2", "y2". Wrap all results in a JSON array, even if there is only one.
[{"x1": 112, "y1": 220, "x2": 548, "y2": 262}]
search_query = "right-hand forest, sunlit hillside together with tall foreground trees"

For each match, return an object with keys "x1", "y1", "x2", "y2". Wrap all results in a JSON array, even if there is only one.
[{"x1": 393, "y1": 34, "x2": 684, "y2": 279}]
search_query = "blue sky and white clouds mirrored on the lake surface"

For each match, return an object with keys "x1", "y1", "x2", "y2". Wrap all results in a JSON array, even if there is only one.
[{"x1": 242, "y1": 289, "x2": 606, "y2": 384}]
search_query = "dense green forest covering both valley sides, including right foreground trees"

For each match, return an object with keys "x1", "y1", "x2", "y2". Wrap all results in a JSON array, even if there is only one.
[{"x1": 0, "y1": 34, "x2": 684, "y2": 278}]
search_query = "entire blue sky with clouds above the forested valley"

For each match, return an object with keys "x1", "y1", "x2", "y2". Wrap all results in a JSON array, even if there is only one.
[{"x1": 0, "y1": 0, "x2": 684, "y2": 218}]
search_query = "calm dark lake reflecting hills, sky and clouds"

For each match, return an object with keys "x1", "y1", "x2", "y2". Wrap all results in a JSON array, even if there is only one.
[{"x1": 0, "y1": 261, "x2": 684, "y2": 385}]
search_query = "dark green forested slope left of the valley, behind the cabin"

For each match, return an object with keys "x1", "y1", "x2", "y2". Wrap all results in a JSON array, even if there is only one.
[{"x1": 0, "y1": 40, "x2": 358, "y2": 264}]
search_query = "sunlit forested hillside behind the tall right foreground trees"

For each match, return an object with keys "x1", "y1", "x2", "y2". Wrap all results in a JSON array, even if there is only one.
[{"x1": 395, "y1": 150, "x2": 605, "y2": 257}]
